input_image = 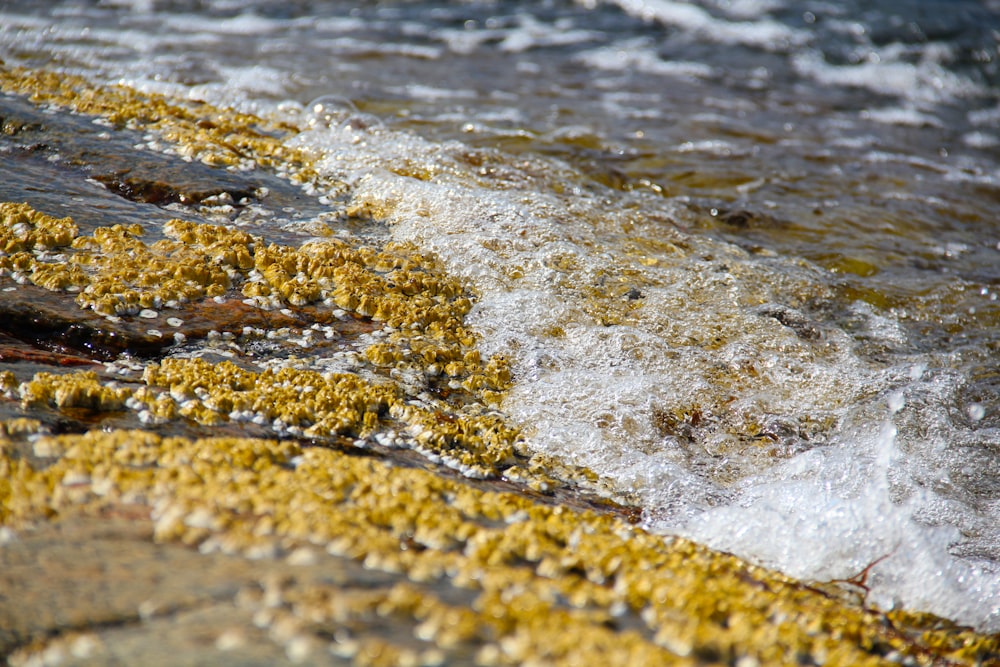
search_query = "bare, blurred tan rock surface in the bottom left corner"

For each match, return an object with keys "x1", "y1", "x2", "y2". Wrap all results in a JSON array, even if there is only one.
[{"x1": 0, "y1": 506, "x2": 444, "y2": 666}]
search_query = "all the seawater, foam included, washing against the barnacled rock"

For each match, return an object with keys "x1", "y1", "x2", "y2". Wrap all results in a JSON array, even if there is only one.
[{"x1": 0, "y1": 0, "x2": 1000, "y2": 631}]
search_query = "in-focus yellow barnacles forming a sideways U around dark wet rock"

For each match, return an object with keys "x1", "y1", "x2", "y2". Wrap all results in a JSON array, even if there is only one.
[{"x1": 4, "y1": 198, "x2": 518, "y2": 476}]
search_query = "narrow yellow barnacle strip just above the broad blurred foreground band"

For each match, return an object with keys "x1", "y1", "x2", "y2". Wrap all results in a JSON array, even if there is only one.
[{"x1": 18, "y1": 357, "x2": 516, "y2": 481}]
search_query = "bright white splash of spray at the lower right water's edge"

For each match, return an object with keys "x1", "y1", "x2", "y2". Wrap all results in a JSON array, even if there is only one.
[{"x1": 682, "y1": 422, "x2": 1000, "y2": 632}]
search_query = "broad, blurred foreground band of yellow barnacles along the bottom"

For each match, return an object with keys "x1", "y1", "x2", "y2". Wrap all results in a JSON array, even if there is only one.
[{"x1": 0, "y1": 431, "x2": 1000, "y2": 665}]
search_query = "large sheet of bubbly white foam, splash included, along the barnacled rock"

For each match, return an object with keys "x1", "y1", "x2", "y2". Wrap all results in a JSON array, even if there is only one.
[{"x1": 294, "y1": 117, "x2": 1000, "y2": 628}]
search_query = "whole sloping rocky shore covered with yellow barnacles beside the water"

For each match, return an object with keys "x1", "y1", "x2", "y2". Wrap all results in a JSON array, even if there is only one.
[{"x1": 0, "y1": 66, "x2": 1000, "y2": 666}]
